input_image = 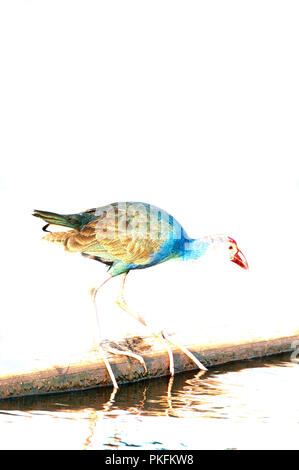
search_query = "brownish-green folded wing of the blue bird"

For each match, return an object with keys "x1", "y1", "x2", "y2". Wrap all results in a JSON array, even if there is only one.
[{"x1": 44, "y1": 206, "x2": 169, "y2": 265}]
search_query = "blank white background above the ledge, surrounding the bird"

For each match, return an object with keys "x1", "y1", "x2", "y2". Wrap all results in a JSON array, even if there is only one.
[{"x1": 0, "y1": 0, "x2": 299, "y2": 367}]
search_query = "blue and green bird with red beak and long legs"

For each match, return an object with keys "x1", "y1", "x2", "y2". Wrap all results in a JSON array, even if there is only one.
[{"x1": 33, "y1": 201, "x2": 248, "y2": 389}]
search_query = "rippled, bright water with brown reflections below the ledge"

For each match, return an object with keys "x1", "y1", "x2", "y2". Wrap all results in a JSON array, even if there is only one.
[{"x1": 0, "y1": 353, "x2": 299, "y2": 450}]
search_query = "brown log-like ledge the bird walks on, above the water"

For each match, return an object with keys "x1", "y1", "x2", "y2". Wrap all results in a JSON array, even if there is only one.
[{"x1": 0, "y1": 331, "x2": 299, "y2": 399}]
